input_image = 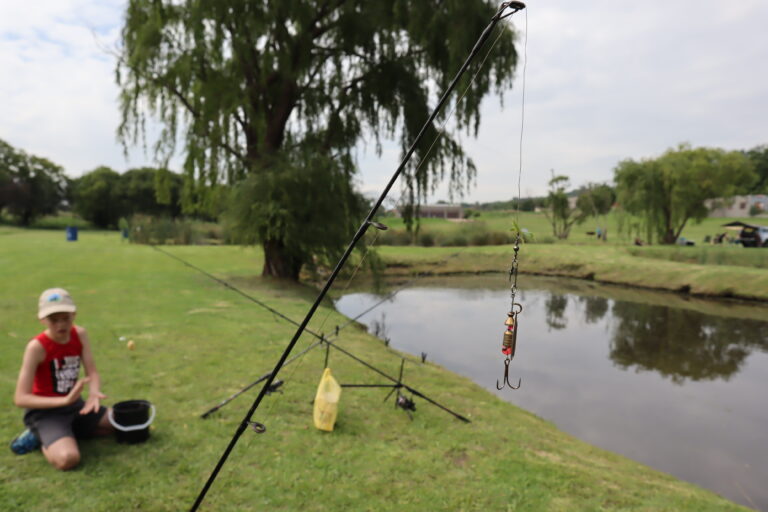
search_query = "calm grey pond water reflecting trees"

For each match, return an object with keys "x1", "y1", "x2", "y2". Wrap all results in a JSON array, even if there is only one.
[{"x1": 336, "y1": 276, "x2": 768, "y2": 511}]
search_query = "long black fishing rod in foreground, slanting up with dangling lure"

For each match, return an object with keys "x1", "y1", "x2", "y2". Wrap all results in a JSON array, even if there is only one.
[{"x1": 191, "y1": 1, "x2": 525, "y2": 512}]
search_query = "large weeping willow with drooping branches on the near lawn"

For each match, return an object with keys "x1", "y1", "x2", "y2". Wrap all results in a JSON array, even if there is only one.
[{"x1": 117, "y1": 0, "x2": 517, "y2": 279}]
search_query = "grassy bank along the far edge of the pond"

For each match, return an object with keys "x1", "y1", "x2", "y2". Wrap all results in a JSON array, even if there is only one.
[{"x1": 380, "y1": 244, "x2": 768, "y2": 301}]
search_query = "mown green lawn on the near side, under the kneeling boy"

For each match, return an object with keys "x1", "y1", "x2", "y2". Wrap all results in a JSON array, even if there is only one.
[{"x1": 0, "y1": 228, "x2": 744, "y2": 511}]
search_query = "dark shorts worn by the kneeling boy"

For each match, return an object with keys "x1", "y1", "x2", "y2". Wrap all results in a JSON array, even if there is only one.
[{"x1": 24, "y1": 400, "x2": 107, "y2": 448}]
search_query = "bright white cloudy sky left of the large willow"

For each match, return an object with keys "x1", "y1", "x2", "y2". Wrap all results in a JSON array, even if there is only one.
[{"x1": 0, "y1": 0, "x2": 156, "y2": 176}]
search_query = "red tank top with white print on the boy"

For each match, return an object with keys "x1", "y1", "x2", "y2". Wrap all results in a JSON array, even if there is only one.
[{"x1": 32, "y1": 327, "x2": 83, "y2": 396}]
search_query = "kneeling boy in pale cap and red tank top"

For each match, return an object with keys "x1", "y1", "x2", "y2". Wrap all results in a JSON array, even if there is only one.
[{"x1": 11, "y1": 288, "x2": 112, "y2": 470}]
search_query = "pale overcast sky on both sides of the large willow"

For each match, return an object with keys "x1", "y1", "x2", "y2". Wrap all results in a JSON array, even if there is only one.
[{"x1": 0, "y1": 0, "x2": 768, "y2": 202}]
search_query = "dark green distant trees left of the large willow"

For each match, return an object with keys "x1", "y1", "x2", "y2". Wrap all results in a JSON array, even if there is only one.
[{"x1": 0, "y1": 140, "x2": 183, "y2": 228}]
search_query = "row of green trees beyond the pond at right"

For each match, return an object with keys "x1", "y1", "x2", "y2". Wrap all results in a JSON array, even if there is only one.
[{"x1": 464, "y1": 144, "x2": 768, "y2": 244}]
